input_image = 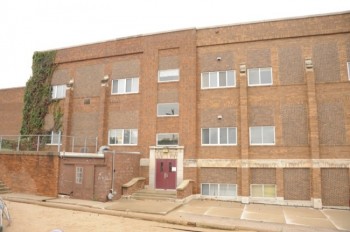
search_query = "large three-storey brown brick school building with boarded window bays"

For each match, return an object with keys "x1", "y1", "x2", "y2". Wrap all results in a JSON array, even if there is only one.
[{"x1": 1, "y1": 12, "x2": 350, "y2": 208}]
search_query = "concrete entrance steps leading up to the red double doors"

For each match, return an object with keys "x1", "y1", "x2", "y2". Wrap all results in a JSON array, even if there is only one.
[{"x1": 131, "y1": 189, "x2": 176, "y2": 201}]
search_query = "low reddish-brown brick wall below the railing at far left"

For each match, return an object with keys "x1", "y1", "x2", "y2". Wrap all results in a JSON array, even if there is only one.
[{"x1": 0, "y1": 152, "x2": 60, "y2": 196}]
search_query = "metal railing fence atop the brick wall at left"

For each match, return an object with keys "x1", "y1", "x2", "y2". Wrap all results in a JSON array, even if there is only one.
[{"x1": 0, "y1": 135, "x2": 98, "y2": 153}]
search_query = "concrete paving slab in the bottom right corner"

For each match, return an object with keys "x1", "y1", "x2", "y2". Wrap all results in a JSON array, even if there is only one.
[{"x1": 321, "y1": 209, "x2": 350, "y2": 231}]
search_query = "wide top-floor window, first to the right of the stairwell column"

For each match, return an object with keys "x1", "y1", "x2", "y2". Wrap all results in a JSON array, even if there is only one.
[{"x1": 202, "y1": 70, "x2": 236, "y2": 89}]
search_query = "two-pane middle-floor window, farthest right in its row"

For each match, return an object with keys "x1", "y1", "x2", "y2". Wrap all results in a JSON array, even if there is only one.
[{"x1": 249, "y1": 126, "x2": 275, "y2": 145}]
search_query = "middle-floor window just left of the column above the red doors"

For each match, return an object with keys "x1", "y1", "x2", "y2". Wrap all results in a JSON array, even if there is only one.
[{"x1": 108, "y1": 129, "x2": 138, "y2": 145}]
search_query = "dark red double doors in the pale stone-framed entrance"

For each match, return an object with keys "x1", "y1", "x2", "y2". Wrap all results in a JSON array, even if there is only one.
[{"x1": 156, "y1": 159, "x2": 177, "y2": 189}]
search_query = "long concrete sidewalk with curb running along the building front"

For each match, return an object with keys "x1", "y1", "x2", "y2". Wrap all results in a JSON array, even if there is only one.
[{"x1": 1, "y1": 193, "x2": 350, "y2": 232}]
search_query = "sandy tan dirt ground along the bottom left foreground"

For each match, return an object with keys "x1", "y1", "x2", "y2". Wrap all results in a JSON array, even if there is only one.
[{"x1": 4, "y1": 202, "x2": 246, "y2": 232}]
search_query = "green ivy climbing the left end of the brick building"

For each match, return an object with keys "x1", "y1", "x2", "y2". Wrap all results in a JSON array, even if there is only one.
[{"x1": 21, "y1": 51, "x2": 56, "y2": 135}]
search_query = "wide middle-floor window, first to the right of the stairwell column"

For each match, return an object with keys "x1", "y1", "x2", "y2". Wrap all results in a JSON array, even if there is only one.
[{"x1": 202, "y1": 127, "x2": 237, "y2": 145}]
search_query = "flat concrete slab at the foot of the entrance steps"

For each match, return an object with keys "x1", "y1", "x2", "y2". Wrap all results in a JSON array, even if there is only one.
[{"x1": 105, "y1": 199, "x2": 182, "y2": 215}]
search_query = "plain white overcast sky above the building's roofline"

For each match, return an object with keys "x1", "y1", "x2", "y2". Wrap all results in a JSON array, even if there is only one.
[{"x1": 0, "y1": 0, "x2": 350, "y2": 89}]
